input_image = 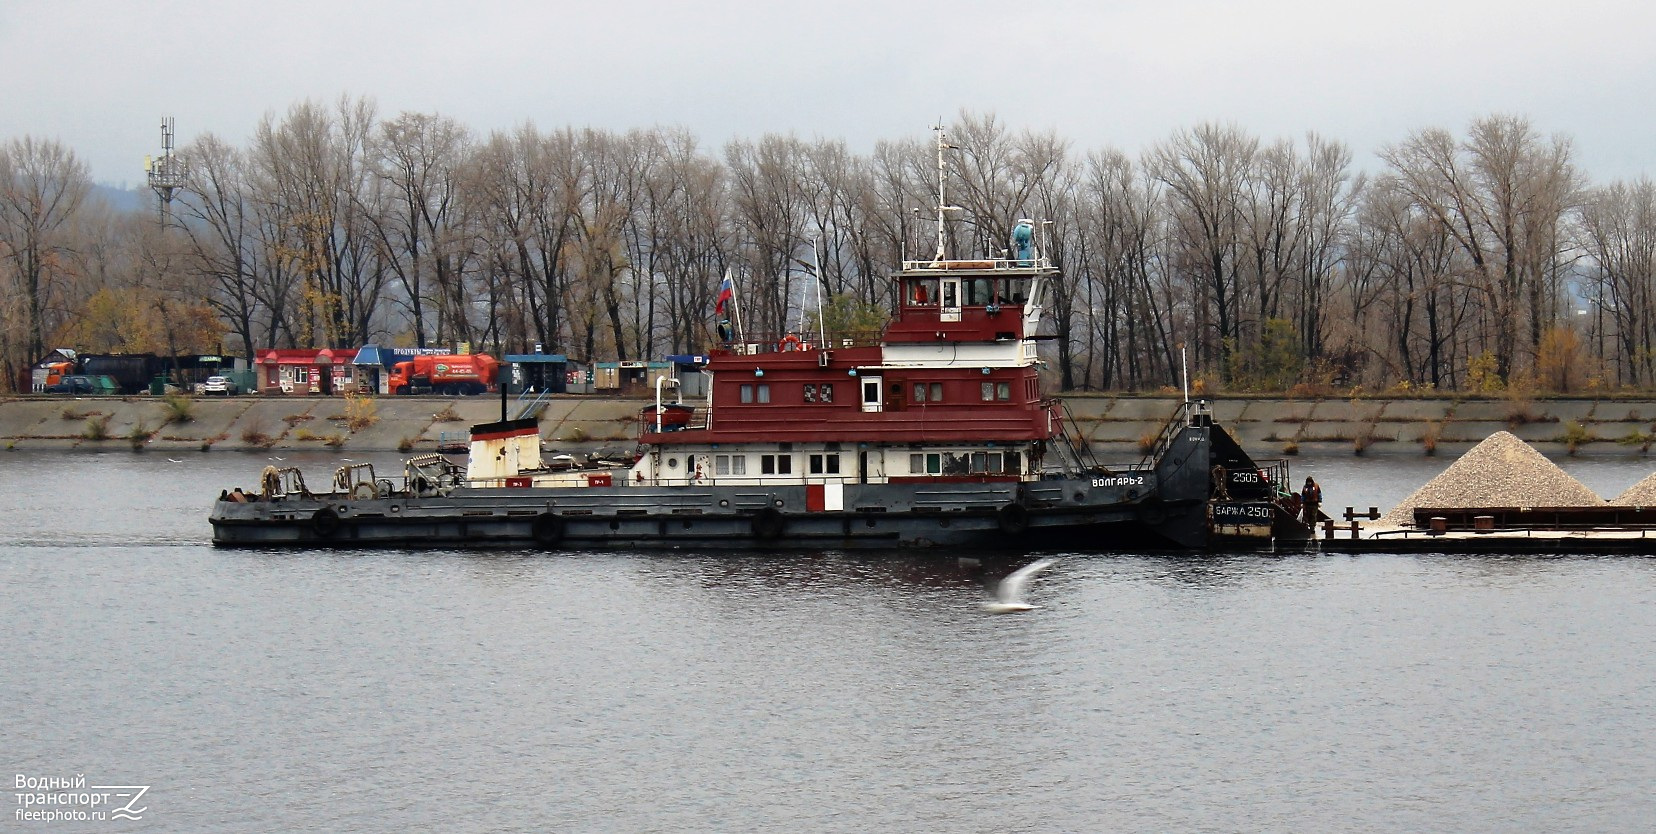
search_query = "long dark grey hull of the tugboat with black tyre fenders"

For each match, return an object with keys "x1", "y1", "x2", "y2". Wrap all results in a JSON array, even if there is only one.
[{"x1": 210, "y1": 478, "x2": 1206, "y2": 551}]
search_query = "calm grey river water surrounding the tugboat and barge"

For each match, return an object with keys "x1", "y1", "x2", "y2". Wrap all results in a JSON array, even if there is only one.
[{"x1": 0, "y1": 452, "x2": 1656, "y2": 832}]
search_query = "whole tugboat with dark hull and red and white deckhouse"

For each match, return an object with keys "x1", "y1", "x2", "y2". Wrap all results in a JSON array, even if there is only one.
[{"x1": 210, "y1": 134, "x2": 1310, "y2": 551}]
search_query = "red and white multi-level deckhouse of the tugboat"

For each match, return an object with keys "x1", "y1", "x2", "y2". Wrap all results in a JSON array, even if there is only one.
[{"x1": 634, "y1": 248, "x2": 1061, "y2": 485}]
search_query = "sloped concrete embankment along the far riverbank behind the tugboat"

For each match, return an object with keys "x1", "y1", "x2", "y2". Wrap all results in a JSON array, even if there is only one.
[{"x1": 0, "y1": 395, "x2": 1656, "y2": 460}]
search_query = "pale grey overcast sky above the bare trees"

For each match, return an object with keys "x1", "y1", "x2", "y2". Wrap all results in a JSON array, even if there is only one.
[{"x1": 0, "y1": 0, "x2": 1656, "y2": 185}]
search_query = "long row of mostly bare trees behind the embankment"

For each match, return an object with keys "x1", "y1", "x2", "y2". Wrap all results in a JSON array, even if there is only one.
[{"x1": 0, "y1": 98, "x2": 1656, "y2": 391}]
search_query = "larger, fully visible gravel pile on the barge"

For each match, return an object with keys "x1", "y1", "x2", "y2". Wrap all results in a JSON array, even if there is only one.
[{"x1": 1381, "y1": 432, "x2": 1603, "y2": 526}]
